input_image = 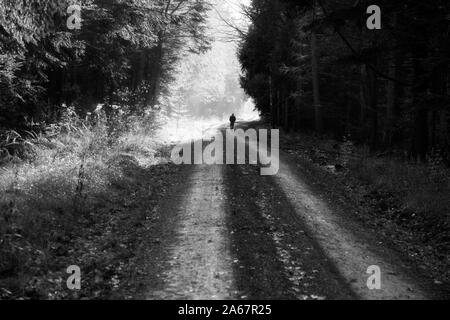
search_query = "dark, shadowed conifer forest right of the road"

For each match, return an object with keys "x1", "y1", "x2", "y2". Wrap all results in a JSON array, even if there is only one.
[{"x1": 239, "y1": 0, "x2": 450, "y2": 160}]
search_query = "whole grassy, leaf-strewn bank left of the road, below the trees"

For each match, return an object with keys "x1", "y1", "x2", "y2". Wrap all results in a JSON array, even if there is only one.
[{"x1": 0, "y1": 108, "x2": 171, "y2": 299}]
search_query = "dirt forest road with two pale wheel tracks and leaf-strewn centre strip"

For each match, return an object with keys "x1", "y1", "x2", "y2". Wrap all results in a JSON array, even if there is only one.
[{"x1": 138, "y1": 123, "x2": 446, "y2": 300}]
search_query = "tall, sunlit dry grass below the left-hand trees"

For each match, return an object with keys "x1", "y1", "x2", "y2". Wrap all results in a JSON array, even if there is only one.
[{"x1": 0, "y1": 108, "x2": 164, "y2": 292}]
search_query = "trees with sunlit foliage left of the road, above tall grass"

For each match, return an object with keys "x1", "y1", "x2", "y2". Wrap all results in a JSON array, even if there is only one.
[{"x1": 0, "y1": 0, "x2": 210, "y2": 129}]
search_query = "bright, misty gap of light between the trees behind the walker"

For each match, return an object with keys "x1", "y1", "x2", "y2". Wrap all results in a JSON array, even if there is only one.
[{"x1": 159, "y1": 0, "x2": 259, "y2": 143}]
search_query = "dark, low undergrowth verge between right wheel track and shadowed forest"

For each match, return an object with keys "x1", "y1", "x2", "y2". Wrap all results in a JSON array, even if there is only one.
[{"x1": 282, "y1": 130, "x2": 450, "y2": 285}]
